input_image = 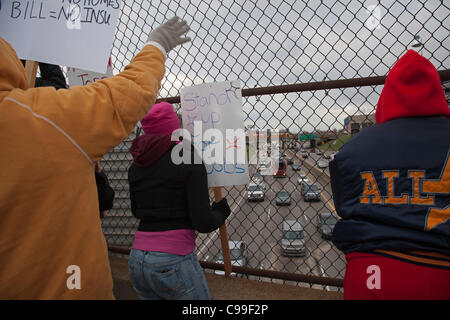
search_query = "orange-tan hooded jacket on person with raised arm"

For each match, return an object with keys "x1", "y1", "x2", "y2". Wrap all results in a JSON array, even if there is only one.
[{"x1": 0, "y1": 38, "x2": 165, "y2": 299}]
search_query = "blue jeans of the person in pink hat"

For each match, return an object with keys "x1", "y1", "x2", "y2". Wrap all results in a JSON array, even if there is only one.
[{"x1": 128, "y1": 249, "x2": 211, "y2": 300}]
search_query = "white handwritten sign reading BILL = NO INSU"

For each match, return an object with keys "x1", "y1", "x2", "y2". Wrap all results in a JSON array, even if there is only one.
[{"x1": 0, "y1": 0, "x2": 121, "y2": 73}]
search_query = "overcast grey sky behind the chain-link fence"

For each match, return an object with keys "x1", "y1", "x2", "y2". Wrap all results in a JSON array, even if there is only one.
[{"x1": 113, "y1": 0, "x2": 450, "y2": 131}]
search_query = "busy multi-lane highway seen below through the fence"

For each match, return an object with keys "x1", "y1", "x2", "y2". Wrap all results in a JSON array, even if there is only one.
[{"x1": 197, "y1": 150, "x2": 345, "y2": 289}]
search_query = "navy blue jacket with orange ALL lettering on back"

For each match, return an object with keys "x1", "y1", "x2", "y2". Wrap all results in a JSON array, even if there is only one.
[{"x1": 329, "y1": 117, "x2": 450, "y2": 255}]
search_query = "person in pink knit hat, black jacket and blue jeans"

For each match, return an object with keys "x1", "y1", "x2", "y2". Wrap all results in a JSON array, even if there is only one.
[{"x1": 128, "y1": 102, "x2": 231, "y2": 300}]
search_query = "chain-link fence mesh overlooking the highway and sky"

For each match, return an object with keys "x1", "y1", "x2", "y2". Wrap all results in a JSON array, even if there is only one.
[{"x1": 101, "y1": 0, "x2": 450, "y2": 289}]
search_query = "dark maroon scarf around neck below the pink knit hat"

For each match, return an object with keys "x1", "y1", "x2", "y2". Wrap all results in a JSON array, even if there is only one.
[{"x1": 130, "y1": 134, "x2": 176, "y2": 167}]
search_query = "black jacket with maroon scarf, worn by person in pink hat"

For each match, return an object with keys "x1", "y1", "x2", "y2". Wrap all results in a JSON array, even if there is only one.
[{"x1": 128, "y1": 134, "x2": 231, "y2": 233}]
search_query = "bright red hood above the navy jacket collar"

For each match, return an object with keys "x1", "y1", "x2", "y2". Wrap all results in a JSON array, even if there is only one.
[{"x1": 375, "y1": 50, "x2": 450, "y2": 123}]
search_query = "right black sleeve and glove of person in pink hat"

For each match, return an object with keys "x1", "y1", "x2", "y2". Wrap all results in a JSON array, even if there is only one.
[{"x1": 186, "y1": 164, "x2": 231, "y2": 233}]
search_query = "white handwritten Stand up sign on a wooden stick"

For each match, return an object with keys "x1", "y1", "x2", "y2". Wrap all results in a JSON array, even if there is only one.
[{"x1": 180, "y1": 81, "x2": 249, "y2": 187}]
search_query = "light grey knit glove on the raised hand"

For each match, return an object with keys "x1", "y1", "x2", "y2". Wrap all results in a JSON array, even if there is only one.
[{"x1": 147, "y1": 16, "x2": 191, "y2": 58}]
